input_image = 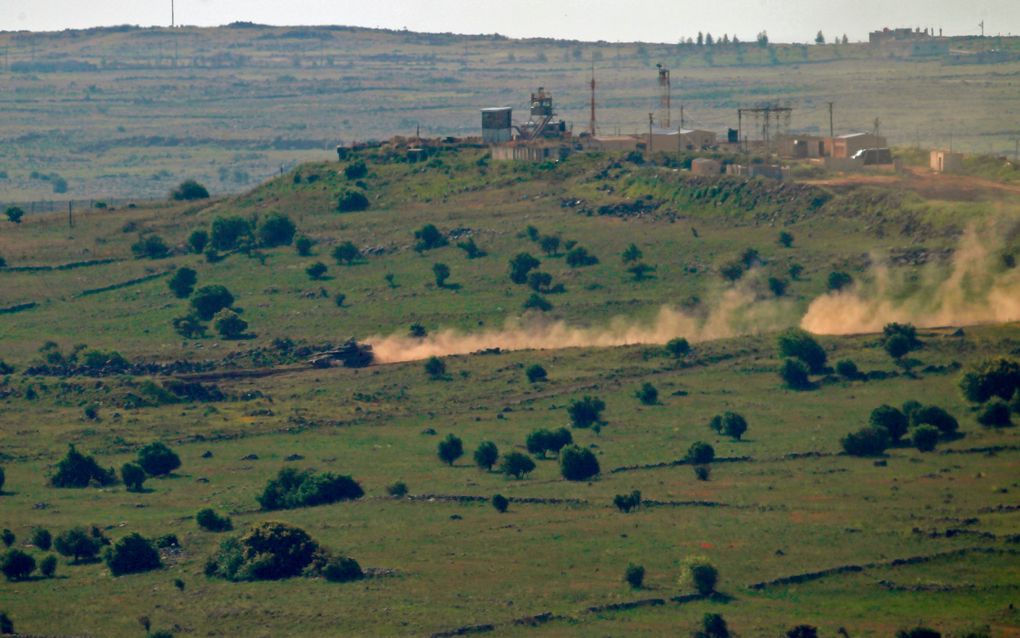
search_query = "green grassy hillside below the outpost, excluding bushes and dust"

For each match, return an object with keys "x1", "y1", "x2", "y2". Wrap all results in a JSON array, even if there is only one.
[{"x1": 0, "y1": 148, "x2": 1020, "y2": 636}]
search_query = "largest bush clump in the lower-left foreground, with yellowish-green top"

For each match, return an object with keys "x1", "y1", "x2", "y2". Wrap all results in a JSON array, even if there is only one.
[{"x1": 205, "y1": 522, "x2": 364, "y2": 582}]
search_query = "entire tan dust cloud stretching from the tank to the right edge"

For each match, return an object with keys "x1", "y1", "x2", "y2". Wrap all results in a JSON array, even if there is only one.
[{"x1": 366, "y1": 226, "x2": 1020, "y2": 363}]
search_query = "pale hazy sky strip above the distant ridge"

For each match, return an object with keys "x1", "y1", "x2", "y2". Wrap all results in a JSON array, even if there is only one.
[{"x1": 0, "y1": 0, "x2": 1020, "y2": 42}]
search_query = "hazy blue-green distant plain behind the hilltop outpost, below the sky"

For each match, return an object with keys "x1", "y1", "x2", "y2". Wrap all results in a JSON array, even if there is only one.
[{"x1": 0, "y1": 27, "x2": 1020, "y2": 201}]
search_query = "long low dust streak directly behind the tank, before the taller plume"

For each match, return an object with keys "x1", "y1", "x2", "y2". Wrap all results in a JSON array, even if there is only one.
[{"x1": 366, "y1": 277, "x2": 796, "y2": 363}]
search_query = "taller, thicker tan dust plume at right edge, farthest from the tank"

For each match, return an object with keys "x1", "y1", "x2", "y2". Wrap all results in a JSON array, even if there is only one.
[{"x1": 801, "y1": 226, "x2": 1020, "y2": 335}]
